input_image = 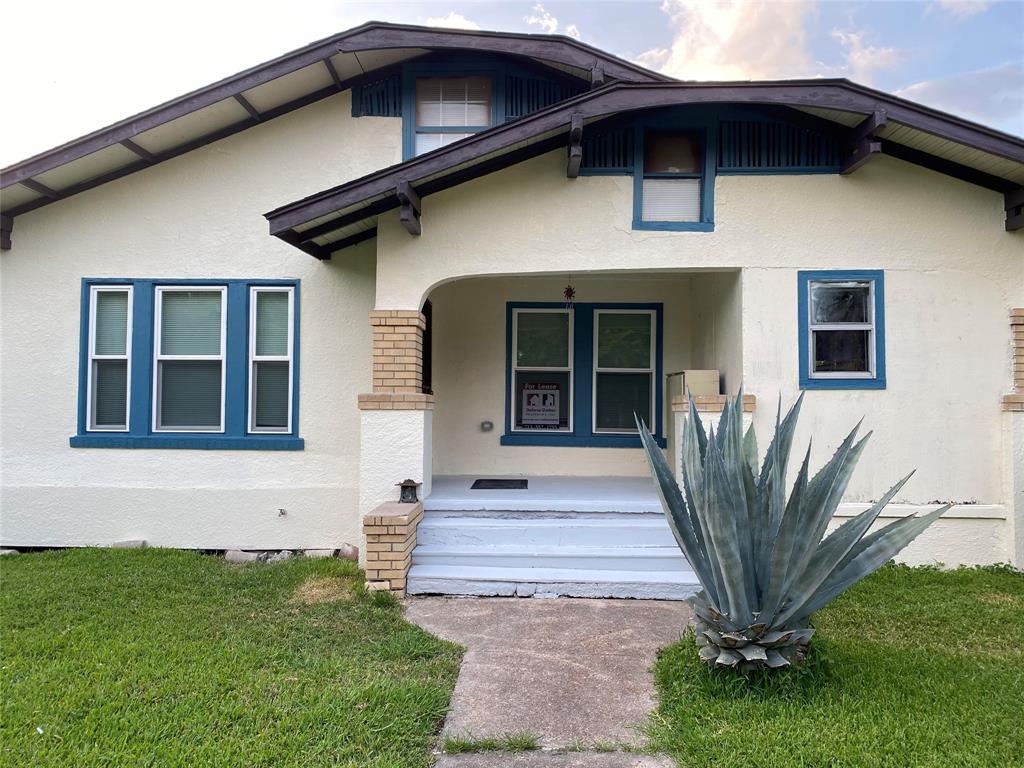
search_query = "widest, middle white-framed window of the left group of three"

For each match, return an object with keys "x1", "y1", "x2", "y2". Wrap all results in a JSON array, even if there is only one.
[{"x1": 154, "y1": 287, "x2": 227, "y2": 432}]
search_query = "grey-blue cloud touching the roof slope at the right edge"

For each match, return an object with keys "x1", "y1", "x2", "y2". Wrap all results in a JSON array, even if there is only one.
[{"x1": 896, "y1": 61, "x2": 1024, "y2": 134}]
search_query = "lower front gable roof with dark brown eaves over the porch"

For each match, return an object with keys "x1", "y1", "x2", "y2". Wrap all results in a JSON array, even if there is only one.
[{"x1": 264, "y1": 79, "x2": 1024, "y2": 259}]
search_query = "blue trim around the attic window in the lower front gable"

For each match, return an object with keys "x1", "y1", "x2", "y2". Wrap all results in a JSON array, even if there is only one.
[{"x1": 633, "y1": 112, "x2": 718, "y2": 232}]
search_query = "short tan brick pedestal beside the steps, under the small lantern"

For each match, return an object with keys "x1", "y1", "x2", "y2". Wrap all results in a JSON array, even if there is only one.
[{"x1": 362, "y1": 502, "x2": 423, "y2": 597}]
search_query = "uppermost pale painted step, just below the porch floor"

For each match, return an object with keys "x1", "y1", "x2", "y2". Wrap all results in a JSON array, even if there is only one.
[{"x1": 417, "y1": 512, "x2": 676, "y2": 547}]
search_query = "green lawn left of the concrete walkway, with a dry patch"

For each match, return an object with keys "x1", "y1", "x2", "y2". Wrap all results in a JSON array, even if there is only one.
[{"x1": 0, "y1": 550, "x2": 461, "y2": 768}]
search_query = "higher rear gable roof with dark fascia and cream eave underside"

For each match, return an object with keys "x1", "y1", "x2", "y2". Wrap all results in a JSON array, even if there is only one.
[{"x1": 0, "y1": 22, "x2": 668, "y2": 217}]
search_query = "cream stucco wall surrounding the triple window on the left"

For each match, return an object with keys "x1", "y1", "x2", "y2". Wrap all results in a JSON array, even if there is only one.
[{"x1": 0, "y1": 93, "x2": 401, "y2": 548}]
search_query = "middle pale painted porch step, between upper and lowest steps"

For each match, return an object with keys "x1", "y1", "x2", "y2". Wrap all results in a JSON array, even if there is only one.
[{"x1": 413, "y1": 542, "x2": 690, "y2": 572}]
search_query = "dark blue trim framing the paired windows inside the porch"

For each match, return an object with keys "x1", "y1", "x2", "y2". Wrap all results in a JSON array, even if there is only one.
[{"x1": 501, "y1": 301, "x2": 668, "y2": 449}]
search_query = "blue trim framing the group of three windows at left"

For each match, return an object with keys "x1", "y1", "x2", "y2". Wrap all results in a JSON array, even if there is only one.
[{"x1": 70, "y1": 278, "x2": 305, "y2": 451}]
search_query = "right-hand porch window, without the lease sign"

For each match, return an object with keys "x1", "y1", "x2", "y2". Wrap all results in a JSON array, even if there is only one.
[{"x1": 594, "y1": 309, "x2": 655, "y2": 433}]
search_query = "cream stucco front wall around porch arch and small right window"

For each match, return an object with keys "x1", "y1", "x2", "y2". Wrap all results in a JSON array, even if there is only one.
[{"x1": 377, "y1": 153, "x2": 1024, "y2": 514}]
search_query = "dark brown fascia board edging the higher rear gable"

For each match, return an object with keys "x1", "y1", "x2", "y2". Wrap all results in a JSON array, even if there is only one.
[{"x1": 0, "y1": 22, "x2": 669, "y2": 188}]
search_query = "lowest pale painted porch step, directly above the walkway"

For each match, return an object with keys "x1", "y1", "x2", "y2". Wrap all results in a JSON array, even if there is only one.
[{"x1": 406, "y1": 563, "x2": 700, "y2": 600}]
